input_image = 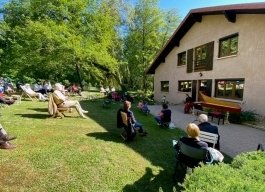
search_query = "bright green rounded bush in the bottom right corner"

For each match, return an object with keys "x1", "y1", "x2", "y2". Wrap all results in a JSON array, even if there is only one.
[{"x1": 183, "y1": 151, "x2": 265, "y2": 192}]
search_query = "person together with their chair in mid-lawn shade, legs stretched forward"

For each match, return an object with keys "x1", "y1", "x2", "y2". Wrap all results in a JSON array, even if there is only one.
[{"x1": 117, "y1": 101, "x2": 147, "y2": 141}]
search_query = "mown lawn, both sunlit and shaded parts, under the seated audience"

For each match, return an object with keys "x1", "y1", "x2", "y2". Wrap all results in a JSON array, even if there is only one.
[{"x1": 0, "y1": 96, "x2": 231, "y2": 192}]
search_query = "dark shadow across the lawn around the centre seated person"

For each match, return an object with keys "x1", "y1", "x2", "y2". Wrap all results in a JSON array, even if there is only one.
[{"x1": 80, "y1": 100, "x2": 181, "y2": 192}]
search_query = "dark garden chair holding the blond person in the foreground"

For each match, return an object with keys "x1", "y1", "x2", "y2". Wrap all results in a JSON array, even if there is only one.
[{"x1": 173, "y1": 140, "x2": 212, "y2": 182}]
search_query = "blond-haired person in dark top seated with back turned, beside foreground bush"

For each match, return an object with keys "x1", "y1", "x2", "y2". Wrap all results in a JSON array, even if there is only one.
[{"x1": 174, "y1": 123, "x2": 208, "y2": 168}]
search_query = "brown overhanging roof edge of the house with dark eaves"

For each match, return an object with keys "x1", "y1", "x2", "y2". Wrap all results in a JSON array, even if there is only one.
[{"x1": 146, "y1": 3, "x2": 265, "y2": 74}]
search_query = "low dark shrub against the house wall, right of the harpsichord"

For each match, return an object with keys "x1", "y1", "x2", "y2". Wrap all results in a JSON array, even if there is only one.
[{"x1": 229, "y1": 111, "x2": 258, "y2": 124}]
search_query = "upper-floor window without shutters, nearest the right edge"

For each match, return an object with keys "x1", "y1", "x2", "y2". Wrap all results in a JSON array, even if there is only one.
[{"x1": 219, "y1": 33, "x2": 238, "y2": 58}]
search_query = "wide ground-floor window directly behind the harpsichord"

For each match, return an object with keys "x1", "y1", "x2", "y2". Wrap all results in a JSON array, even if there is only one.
[{"x1": 215, "y1": 79, "x2": 244, "y2": 100}]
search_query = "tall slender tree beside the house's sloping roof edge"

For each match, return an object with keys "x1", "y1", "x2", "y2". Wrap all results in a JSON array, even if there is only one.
[{"x1": 124, "y1": 0, "x2": 179, "y2": 91}]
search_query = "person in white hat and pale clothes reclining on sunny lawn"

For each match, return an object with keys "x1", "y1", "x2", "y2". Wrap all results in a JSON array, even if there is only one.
[{"x1": 53, "y1": 83, "x2": 88, "y2": 119}]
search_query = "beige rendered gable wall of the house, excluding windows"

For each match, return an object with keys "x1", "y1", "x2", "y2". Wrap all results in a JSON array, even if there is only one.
[{"x1": 155, "y1": 15, "x2": 265, "y2": 115}]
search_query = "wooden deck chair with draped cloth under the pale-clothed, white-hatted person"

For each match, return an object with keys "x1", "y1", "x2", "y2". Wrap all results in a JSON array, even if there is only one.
[{"x1": 48, "y1": 94, "x2": 69, "y2": 118}]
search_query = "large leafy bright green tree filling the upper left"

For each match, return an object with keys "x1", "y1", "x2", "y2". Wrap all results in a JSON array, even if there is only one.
[{"x1": 0, "y1": 0, "x2": 119, "y2": 87}]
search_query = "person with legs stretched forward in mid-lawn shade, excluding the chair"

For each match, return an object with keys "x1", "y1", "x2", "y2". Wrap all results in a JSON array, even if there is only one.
[{"x1": 119, "y1": 101, "x2": 147, "y2": 136}]
